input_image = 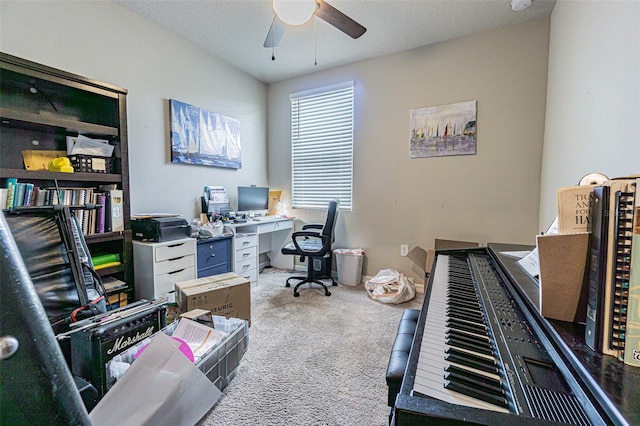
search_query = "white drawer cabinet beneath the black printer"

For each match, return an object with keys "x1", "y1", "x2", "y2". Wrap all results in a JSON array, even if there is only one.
[{"x1": 133, "y1": 238, "x2": 196, "y2": 302}]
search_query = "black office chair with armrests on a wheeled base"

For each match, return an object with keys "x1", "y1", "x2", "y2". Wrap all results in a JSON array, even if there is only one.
[{"x1": 282, "y1": 201, "x2": 338, "y2": 297}]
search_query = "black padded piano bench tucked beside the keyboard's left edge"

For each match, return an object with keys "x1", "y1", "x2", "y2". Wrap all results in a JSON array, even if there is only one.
[{"x1": 387, "y1": 309, "x2": 420, "y2": 411}]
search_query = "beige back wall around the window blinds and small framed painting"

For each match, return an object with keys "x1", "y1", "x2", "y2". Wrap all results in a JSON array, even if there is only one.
[{"x1": 268, "y1": 20, "x2": 549, "y2": 278}]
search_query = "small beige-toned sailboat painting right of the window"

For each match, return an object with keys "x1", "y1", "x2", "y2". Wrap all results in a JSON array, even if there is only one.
[{"x1": 410, "y1": 101, "x2": 477, "y2": 158}]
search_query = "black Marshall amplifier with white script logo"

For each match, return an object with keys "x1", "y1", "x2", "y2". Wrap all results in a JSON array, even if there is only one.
[{"x1": 69, "y1": 301, "x2": 167, "y2": 397}]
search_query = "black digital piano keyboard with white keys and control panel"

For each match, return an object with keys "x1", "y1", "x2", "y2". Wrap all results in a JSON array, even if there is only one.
[{"x1": 393, "y1": 249, "x2": 604, "y2": 425}]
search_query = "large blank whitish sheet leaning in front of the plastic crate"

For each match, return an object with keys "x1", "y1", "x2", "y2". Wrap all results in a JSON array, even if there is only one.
[{"x1": 89, "y1": 332, "x2": 222, "y2": 426}]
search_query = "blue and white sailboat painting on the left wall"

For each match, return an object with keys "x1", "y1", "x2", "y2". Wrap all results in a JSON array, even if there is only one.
[{"x1": 169, "y1": 99, "x2": 242, "y2": 169}]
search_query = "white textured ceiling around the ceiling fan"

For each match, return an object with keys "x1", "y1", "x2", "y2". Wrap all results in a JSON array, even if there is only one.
[{"x1": 112, "y1": 0, "x2": 554, "y2": 83}]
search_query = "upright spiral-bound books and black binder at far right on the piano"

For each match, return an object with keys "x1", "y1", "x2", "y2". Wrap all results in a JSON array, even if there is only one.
[{"x1": 572, "y1": 177, "x2": 640, "y2": 366}]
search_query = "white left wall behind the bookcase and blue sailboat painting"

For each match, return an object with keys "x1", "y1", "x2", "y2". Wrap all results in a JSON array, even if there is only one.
[{"x1": 0, "y1": 1, "x2": 267, "y2": 219}]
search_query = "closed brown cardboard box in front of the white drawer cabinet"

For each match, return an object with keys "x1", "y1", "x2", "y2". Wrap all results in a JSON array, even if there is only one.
[{"x1": 175, "y1": 272, "x2": 251, "y2": 324}]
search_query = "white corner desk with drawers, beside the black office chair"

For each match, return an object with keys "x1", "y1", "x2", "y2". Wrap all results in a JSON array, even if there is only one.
[{"x1": 226, "y1": 218, "x2": 293, "y2": 283}]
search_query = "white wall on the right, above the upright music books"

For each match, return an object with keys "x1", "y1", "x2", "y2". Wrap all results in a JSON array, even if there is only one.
[{"x1": 539, "y1": 0, "x2": 640, "y2": 229}]
